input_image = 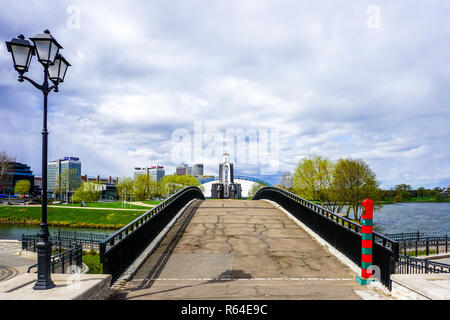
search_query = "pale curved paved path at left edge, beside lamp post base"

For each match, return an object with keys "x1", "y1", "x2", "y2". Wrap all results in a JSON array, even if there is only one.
[{"x1": 0, "y1": 240, "x2": 36, "y2": 282}]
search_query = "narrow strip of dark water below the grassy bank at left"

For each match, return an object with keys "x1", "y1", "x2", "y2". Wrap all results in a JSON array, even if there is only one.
[{"x1": 0, "y1": 223, "x2": 115, "y2": 240}]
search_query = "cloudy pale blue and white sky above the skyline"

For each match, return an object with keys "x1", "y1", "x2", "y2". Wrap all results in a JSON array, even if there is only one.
[{"x1": 0, "y1": 0, "x2": 450, "y2": 188}]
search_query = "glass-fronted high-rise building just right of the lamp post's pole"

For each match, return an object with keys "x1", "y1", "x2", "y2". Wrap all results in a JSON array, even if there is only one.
[{"x1": 47, "y1": 157, "x2": 81, "y2": 192}]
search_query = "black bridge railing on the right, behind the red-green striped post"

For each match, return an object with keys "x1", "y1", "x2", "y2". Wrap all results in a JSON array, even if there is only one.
[{"x1": 253, "y1": 187, "x2": 399, "y2": 290}]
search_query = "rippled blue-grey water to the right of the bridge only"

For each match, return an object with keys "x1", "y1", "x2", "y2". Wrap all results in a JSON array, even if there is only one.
[{"x1": 373, "y1": 203, "x2": 450, "y2": 235}]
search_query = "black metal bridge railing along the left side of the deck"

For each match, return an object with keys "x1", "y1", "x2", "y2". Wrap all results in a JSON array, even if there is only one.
[{"x1": 100, "y1": 186, "x2": 205, "y2": 281}]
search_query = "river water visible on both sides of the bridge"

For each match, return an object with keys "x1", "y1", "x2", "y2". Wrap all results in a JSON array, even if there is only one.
[{"x1": 0, "y1": 203, "x2": 450, "y2": 239}]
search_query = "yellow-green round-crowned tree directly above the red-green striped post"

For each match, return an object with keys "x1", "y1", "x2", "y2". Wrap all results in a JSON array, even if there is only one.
[{"x1": 333, "y1": 159, "x2": 380, "y2": 221}]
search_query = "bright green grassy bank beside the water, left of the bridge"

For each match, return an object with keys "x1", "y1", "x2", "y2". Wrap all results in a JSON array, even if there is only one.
[{"x1": 0, "y1": 206, "x2": 145, "y2": 229}]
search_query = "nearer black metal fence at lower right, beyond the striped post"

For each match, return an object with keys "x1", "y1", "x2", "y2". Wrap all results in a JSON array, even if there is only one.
[{"x1": 395, "y1": 255, "x2": 450, "y2": 274}]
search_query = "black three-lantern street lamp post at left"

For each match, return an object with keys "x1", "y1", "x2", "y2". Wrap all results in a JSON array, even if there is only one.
[{"x1": 6, "y1": 30, "x2": 70, "y2": 290}]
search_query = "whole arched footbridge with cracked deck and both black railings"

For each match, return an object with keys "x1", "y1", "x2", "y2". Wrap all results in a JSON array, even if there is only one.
[{"x1": 100, "y1": 187, "x2": 399, "y2": 299}]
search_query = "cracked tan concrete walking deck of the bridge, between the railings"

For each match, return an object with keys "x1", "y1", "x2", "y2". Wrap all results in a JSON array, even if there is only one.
[{"x1": 114, "y1": 200, "x2": 385, "y2": 299}]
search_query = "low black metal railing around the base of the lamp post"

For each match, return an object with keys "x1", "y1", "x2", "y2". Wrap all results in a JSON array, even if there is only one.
[{"x1": 21, "y1": 235, "x2": 83, "y2": 273}]
